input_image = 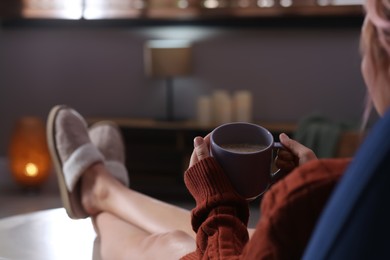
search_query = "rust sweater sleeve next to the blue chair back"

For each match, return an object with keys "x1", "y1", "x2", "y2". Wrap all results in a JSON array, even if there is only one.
[{"x1": 242, "y1": 159, "x2": 350, "y2": 260}]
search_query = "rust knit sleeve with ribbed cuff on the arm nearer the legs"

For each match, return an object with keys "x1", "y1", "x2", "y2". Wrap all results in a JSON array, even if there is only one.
[{"x1": 184, "y1": 157, "x2": 249, "y2": 259}]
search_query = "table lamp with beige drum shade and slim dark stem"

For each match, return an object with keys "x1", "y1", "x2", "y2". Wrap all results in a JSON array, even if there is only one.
[{"x1": 145, "y1": 40, "x2": 192, "y2": 121}]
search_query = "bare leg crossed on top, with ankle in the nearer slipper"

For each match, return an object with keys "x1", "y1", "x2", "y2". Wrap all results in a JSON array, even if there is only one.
[{"x1": 81, "y1": 163, "x2": 195, "y2": 238}]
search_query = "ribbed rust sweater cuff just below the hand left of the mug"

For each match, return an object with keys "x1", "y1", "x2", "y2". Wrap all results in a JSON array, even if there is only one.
[{"x1": 184, "y1": 157, "x2": 236, "y2": 203}]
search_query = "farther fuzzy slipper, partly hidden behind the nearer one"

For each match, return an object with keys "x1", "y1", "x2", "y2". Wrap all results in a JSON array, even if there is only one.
[{"x1": 89, "y1": 121, "x2": 129, "y2": 187}]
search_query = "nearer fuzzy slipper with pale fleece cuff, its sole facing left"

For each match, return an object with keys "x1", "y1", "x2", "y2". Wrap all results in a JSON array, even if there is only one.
[{"x1": 47, "y1": 105, "x2": 104, "y2": 219}]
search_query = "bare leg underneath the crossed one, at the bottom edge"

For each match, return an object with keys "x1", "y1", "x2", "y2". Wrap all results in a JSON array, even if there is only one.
[{"x1": 95, "y1": 212, "x2": 195, "y2": 259}]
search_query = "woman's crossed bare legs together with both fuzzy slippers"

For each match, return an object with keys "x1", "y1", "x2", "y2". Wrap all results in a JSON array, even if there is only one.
[{"x1": 48, "y1": 106, "x2": 256, "y2": 259}]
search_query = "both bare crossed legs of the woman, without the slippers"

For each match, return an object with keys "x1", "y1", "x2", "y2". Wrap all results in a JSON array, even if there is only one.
[{"x1": 81, "y1": 163, "x2": 195, "y2": 259}]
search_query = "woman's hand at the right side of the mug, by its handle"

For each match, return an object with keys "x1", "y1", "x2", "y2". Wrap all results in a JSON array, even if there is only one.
[{"x1": 275, "y1": 133, "x2": 317, "y2": 172}]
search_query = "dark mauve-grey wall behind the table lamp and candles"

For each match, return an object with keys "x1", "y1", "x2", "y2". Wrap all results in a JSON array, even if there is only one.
[{"x1": 0, "y1": 22, "x2": 365, "y2": 156}]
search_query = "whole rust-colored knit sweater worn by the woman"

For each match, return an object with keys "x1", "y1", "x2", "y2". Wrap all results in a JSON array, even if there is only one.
[{"x1": 183, "y1": 157, "x2": 350, "y2": 260}]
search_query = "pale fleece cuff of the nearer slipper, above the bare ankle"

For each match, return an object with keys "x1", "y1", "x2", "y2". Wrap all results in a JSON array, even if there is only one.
[{"x1": 62, "y1": 143, "x2": 104, "y2": 192}]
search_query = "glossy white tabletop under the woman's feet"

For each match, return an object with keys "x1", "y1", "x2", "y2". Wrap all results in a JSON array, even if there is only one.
[{"x1": 0, "y1": 208, "x2": 100, "y2": 260}]
